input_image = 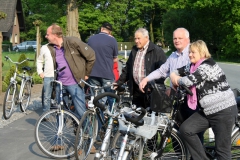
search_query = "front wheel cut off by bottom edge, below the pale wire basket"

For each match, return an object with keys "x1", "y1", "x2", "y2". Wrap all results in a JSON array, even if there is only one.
[{"x1": 110, "y1": 131, "x2": 145, "y2": 160}]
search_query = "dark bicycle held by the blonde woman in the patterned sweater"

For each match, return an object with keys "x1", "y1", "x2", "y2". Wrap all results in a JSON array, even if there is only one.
[{"x1": 148, "y1": 83, "x2": 240, "y2": 160}]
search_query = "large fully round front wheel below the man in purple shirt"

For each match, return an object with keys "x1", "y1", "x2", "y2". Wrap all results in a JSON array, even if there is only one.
[{"x1": 34, "y1": 109, "x2": 79, "y2": 158}]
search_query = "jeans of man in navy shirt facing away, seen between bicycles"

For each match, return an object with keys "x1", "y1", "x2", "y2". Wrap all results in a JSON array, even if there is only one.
[{"x1": 88, "y1": 77, "x2": 114, "y2": 130}]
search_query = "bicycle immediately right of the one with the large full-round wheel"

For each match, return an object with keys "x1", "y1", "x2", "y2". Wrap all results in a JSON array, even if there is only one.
[{"x1": 75, "y1": 80, "x2": 119, "y2": 160}]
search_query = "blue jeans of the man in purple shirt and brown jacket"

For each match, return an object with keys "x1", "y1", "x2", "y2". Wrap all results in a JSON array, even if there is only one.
[{"x1": 56, "y1": 84, "x2": 86, "y2": 119}]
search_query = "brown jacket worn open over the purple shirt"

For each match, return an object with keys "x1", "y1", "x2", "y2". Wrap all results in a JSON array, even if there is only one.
[{"x1": 48, "y1": 37, "x2": 95, "y2": 87}]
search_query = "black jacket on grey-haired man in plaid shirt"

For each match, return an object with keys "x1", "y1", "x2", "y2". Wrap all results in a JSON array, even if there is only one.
[{"x1": 117, "y1": 42, "x2": 167, "y2": 94}]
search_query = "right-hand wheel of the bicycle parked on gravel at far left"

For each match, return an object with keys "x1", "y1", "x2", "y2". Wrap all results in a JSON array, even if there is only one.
[{"x1": 20, "y1": 80, "x2": 32, "y2": 112}]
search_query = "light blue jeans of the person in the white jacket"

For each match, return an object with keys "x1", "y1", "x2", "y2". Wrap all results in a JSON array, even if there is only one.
[{"x1": 42, "y1": 77, "x2": 53, "y2": 112}]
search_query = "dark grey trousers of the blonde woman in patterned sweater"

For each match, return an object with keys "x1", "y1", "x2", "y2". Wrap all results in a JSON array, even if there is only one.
[{"x1": 180, "y1": 106, "x2": 237, "y2": 160}]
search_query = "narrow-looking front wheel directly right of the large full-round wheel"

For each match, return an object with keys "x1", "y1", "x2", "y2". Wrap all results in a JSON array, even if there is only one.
[{"x1": 75, "y1": 110, "x2": 98, "y2": 160}]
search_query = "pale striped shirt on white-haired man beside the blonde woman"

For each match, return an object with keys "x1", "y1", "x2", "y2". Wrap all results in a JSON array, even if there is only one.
[{"x1": 147, "y1": 45, "x2": 190, "y2": 81}]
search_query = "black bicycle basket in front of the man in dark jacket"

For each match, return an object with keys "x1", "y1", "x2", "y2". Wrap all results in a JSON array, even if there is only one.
[{"x1": 150, "y1": 84, "x2": 176, "y2": 113}]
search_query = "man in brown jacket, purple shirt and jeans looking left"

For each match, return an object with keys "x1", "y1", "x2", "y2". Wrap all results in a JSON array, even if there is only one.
[{"x1": 45, "y1": 24, "x2": 95, "y2": 119}]
